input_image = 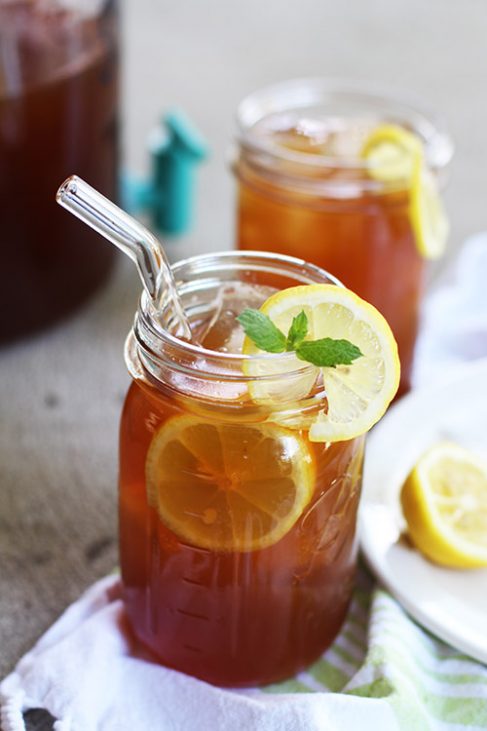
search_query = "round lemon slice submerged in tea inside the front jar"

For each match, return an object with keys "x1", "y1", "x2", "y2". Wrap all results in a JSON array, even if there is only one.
[{"x1": 145, "y1": 415, "x2": 315, "y2": 551}]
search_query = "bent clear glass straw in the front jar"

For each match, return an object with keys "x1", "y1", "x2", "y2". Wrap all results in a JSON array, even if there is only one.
[{"x1": 56, "y1": 175, "x2": 194, "y2": 341}]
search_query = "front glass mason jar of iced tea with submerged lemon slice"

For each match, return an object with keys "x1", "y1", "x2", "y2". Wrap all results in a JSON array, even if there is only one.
[{"x1": 120, "y1": 252, "x2": 364, "y2": 686}]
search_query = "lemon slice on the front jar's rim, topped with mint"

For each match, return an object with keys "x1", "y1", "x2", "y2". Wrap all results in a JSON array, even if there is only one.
[{"x1": 243, "y1": 284, "x2": 400, "y2": 442}]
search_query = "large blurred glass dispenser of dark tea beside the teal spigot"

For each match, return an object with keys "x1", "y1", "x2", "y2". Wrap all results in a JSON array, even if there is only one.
[{"x1": 0, "y1": 0, "x2": 118, "y2": 341}]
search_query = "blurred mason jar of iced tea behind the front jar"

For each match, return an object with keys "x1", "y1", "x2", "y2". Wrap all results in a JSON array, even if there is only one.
[{"x1": 233, "y1": 79, "x2": 452, "y2": 393}]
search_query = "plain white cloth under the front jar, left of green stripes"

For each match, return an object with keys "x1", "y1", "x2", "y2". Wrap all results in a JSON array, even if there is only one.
[{"x1": 0, "y1": 576, "x2": 399, "y2": 731}]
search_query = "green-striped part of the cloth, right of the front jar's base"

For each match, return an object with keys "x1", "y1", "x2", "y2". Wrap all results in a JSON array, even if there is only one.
[{"x1": 264, "y1": 568, "x2": 487, "y2": 731}]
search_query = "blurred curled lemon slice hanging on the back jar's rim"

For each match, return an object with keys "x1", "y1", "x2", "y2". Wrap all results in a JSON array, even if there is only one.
[{"x1": 361, "y1": 124, "x2": 449, "y2": 259}]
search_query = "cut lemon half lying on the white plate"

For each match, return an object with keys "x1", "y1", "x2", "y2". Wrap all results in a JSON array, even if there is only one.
[{"x1": 401, "y1": 443, "x2": 487, "y2": 568}]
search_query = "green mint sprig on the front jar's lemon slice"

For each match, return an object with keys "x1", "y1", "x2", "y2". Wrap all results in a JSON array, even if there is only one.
[{"x1": 237, "y1": 308, "x2": 363, "y2": 368}]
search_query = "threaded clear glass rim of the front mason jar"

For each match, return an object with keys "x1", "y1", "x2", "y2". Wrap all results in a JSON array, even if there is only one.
[{"x1": 132, "y1": 251, "x2": 343, "y2": 382}]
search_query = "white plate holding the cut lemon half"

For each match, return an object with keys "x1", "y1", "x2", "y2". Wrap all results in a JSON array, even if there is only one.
[{"x1": 360, "y1": 359, "x2": 487, "y2": 663}]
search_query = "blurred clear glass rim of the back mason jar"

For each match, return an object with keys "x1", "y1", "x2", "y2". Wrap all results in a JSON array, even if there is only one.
[{"x1": 236, "y1": 77, "x2": 454, "y2": 171}]
